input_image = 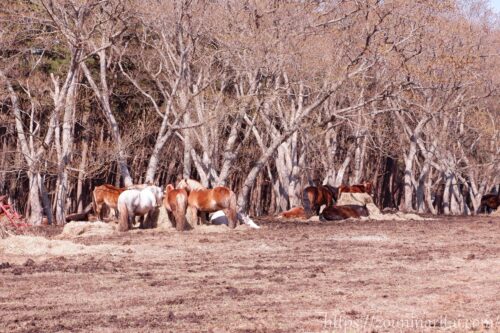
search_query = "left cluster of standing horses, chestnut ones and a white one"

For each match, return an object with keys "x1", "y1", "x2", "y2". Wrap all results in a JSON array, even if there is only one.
[{"x1": 92, "y1": 179, "x2": 237, "y2": 231}]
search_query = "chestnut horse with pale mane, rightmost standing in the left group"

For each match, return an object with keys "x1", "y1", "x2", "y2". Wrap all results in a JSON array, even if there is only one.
[{"x1": 177, "y1": 179, "x2": 237, "y2": 229}]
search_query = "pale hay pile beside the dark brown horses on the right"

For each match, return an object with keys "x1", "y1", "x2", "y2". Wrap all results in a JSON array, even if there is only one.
[{"x1": 337, "y1": 193, "x2": 429, "y2": 221}]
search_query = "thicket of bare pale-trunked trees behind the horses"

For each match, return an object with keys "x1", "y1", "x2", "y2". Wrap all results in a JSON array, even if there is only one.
[{"x1": 0, "y1": 0, "x2": 500, "y2": 223}]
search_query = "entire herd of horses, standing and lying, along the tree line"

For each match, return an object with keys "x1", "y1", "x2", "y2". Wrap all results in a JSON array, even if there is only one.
[{"x1": 92, "y1": 179, "x2": 500, "y2": 231}]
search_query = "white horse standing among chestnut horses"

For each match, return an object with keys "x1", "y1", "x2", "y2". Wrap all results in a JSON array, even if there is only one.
[{"x1": 117, "y1": 185, "x2": 163, "y2": 231}]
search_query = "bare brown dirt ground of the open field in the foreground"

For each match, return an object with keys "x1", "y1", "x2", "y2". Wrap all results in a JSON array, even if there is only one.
[{"x1": 0, "y1": 217, "x2": 500, "y2": 332}]
